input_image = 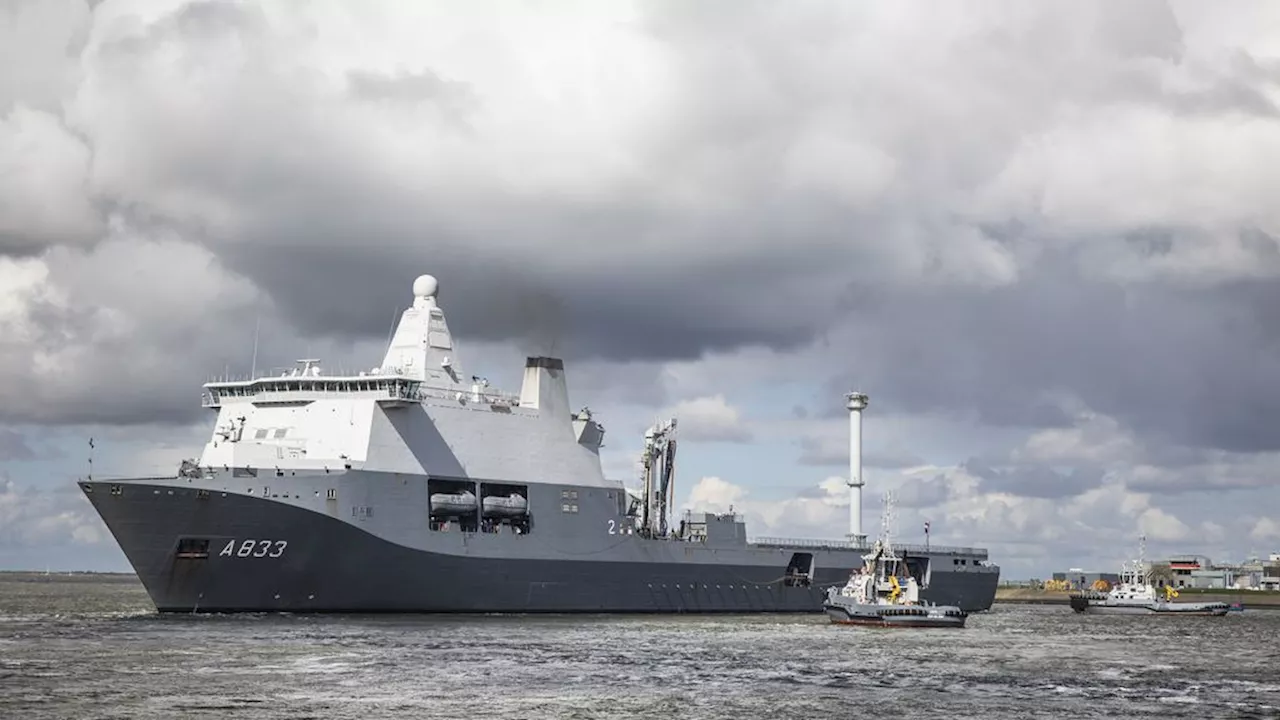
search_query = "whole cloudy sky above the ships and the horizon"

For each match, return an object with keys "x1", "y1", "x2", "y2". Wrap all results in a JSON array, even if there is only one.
[{"x1": 0, "y1": 0, "x2": 1280, "y2": 579}]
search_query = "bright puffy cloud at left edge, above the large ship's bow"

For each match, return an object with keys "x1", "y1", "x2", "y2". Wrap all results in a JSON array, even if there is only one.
[{"x1": 0, "y1": 229, "x2": 261, "y2": 421}]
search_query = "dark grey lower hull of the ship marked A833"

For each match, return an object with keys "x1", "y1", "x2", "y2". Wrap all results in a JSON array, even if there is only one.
[{"x1": 81, "y1": 478, "x2": 998, "y2": 612}]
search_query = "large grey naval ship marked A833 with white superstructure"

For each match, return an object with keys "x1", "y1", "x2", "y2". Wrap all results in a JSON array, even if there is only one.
[{"x1": 79, "y1": 275, "x2": 1000, "y2": 614}]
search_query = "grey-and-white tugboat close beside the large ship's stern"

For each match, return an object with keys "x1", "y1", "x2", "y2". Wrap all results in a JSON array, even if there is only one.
[{"x1": 822, "y1": 493, "x2": 969, "y2": 628}]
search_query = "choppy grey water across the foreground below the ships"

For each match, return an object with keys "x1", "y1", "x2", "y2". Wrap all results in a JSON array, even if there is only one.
[{"x1": 0, "y1": 575, "x2": 1280, "y2": 720}]
